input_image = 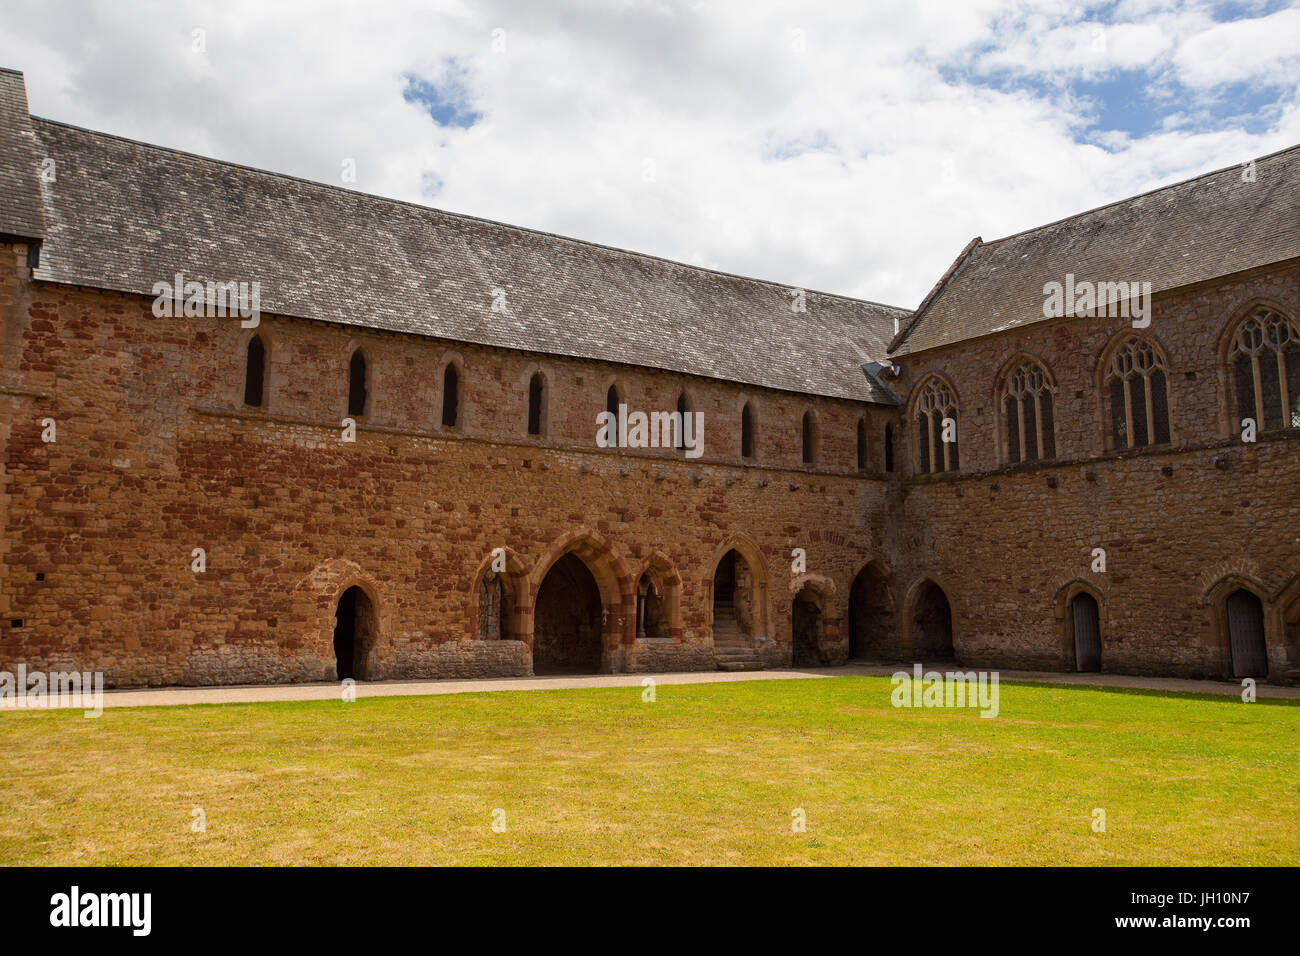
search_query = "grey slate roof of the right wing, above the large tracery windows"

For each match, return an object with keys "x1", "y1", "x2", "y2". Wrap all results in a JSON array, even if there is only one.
[{"x1": 892, "y1": 146, "x2": 1300, "y2": 355}]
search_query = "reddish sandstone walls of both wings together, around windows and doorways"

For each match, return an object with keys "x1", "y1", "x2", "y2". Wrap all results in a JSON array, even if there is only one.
[{"x1": 0, "y1": 240, "x2": 1300, "y2": 685}]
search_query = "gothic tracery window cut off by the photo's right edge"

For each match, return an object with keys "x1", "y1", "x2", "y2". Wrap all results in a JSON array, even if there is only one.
[{"x1": 1229, "y1": 308, "x2": 1300, "y2": 432}]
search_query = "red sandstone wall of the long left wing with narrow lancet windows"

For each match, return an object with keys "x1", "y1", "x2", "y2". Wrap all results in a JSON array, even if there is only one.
[{"x1": 0, "y1": 247, "x2": 889, "y2": 685}]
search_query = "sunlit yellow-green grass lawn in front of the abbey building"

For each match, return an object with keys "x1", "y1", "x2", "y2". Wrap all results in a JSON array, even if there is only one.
[{"x1": 0, "y1": 676, "x2": 1300, "y2": 865}]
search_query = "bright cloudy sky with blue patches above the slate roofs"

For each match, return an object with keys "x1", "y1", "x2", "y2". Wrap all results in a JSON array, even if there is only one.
[{"x1": 0, "y1": 0, "x2": 1300, "y2": 307}]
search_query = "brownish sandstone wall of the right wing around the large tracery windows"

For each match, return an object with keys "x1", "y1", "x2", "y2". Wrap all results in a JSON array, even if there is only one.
[{"x1": 888, "y1": 264, "x2": 1300, "y2": 680}]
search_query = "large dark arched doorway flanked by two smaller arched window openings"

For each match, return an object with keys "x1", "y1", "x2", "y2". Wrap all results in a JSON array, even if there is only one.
[{"x1": 533, "y1": 553, "x2": 603, "y2": 674}]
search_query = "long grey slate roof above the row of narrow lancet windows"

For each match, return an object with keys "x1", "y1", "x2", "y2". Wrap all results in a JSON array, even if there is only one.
[{"x1": 31, "y1": 117, "x2": 910, "y2": 402}]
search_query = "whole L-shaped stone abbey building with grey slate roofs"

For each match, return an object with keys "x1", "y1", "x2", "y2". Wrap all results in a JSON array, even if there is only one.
[{"x1": 0, "y1": 72, "x2": 1300, "y2": 685}]
